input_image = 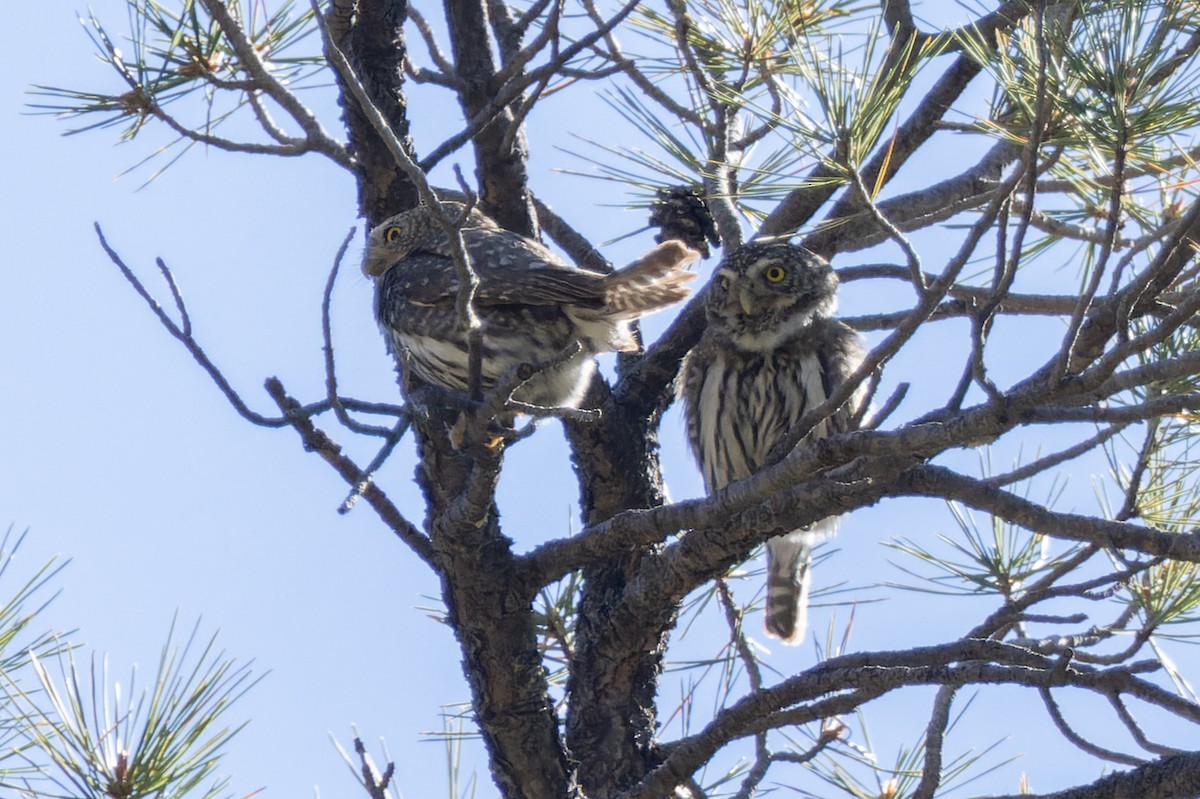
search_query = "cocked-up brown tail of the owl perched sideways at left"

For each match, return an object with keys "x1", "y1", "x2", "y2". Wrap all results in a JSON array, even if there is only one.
[{"x1": 604, "y1": 239, "x2": 700, "y2": 319}]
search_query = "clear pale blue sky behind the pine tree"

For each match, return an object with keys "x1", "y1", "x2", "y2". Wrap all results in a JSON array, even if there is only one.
[{"x1": 0, "y1": 0, "x2": 1195, "y2": 799}]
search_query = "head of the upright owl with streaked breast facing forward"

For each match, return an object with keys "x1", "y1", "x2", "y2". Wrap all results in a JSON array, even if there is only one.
[{"x1": 707, "y1": 244, "x2": 838, "y2": 352}]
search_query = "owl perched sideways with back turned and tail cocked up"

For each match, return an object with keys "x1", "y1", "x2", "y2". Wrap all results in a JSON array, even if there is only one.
[{"x1": 362, "y1": 203, "x2": 697, "y2": 408}]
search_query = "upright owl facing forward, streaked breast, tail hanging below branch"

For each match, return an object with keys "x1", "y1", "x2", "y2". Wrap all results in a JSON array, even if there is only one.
[{"x1": 682, "y1": 244, "x2": 863, "y2": 643}]
